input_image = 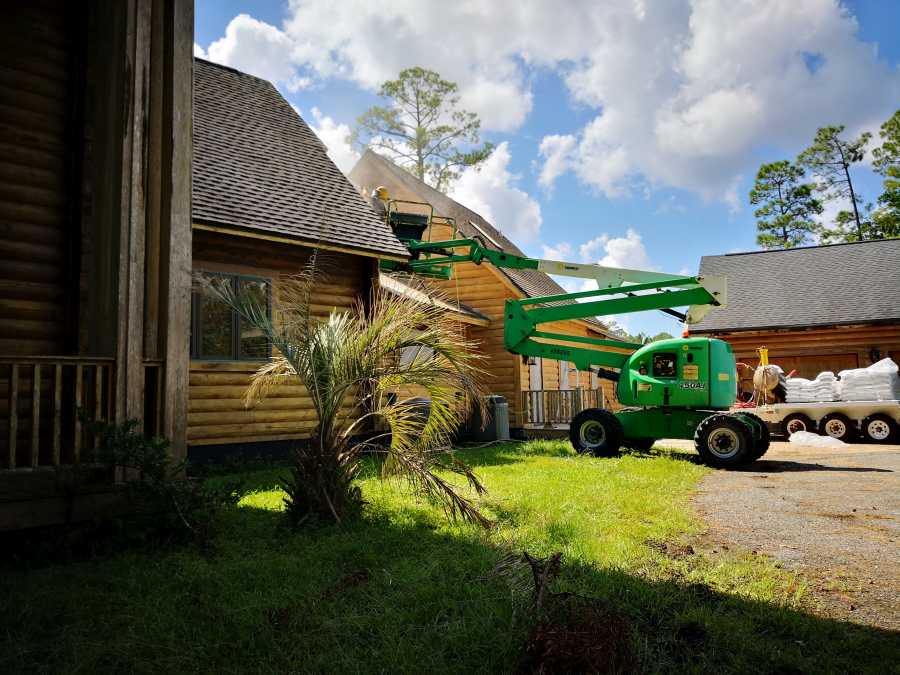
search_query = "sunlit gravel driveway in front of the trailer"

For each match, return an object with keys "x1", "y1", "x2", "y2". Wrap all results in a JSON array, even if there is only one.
[{"x1": 672, "y1": 441, "x2": 900, "y2": 630}]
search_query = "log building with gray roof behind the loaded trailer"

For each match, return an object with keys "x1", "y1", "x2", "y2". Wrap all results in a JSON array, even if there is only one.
[{"x1": 691, "y1": 239, "x2": 900, "y2": 392}]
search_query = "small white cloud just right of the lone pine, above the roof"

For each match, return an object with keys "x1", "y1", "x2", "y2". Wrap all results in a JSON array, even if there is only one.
[{"x1": 449, "y1": 142, "x2": 543, "y2": 244}]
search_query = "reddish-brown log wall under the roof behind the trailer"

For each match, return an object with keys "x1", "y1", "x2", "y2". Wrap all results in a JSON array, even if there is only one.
[{"x1": 711, "y1": 324, "x2": 900, "y2": 390}]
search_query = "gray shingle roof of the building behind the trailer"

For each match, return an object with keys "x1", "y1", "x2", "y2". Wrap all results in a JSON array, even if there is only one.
[{"x1": 691, "y1": 239, "x2": 900, "y2": 332}]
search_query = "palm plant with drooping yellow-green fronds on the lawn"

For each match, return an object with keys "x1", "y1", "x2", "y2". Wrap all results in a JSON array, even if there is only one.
[{"x1": 198, "y1": 256, "x2": 489, "y2": 526}]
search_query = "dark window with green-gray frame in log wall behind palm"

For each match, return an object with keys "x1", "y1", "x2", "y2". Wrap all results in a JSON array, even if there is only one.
[{"x1": 191, "y1": 272, "x2": 272, "y2": 361}]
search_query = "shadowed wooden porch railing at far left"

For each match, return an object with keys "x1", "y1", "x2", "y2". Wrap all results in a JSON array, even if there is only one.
[{"x1": 0, "y1": 356, "x2": 115, "y2": 469}]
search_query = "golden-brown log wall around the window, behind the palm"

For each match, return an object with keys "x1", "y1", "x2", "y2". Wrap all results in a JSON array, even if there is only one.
[{"x1": 185, "y1": 230, "x2": 375, "y2": 445}]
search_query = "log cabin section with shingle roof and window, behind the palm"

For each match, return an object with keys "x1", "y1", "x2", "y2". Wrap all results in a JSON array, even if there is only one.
[{"x1": 192, "y1": 59, "x2": 408, "y2": 456}]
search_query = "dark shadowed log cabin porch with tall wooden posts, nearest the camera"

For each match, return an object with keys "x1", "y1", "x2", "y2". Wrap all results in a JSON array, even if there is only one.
[{"x1": 0, "y1": 0, "x2": 194, "y2": 530}]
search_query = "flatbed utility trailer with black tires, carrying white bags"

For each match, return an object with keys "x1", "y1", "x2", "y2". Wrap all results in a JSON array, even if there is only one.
[{"x1": 732, "y1": 401, "x2": 900, "y2": 443}]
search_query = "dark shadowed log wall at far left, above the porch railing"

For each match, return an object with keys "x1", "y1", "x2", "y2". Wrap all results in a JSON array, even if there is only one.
[{"x1": 0, "y1": 0, "x2": 79, "y2": 356}]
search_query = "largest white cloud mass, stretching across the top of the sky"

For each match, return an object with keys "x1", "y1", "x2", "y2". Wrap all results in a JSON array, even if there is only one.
[{"x1": 200, "y1": 0, "x2": 900, "y2": 206}]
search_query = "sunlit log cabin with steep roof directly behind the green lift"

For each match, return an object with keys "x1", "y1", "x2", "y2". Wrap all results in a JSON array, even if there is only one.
[{"x1": 349, "y1": 150, "x2": 615, "y2": 429}]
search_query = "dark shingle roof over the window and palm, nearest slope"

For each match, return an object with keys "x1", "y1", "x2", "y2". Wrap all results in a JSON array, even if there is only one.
[{"x1": 193, "y1": 59, "x2": 408, "y2": 257}]
